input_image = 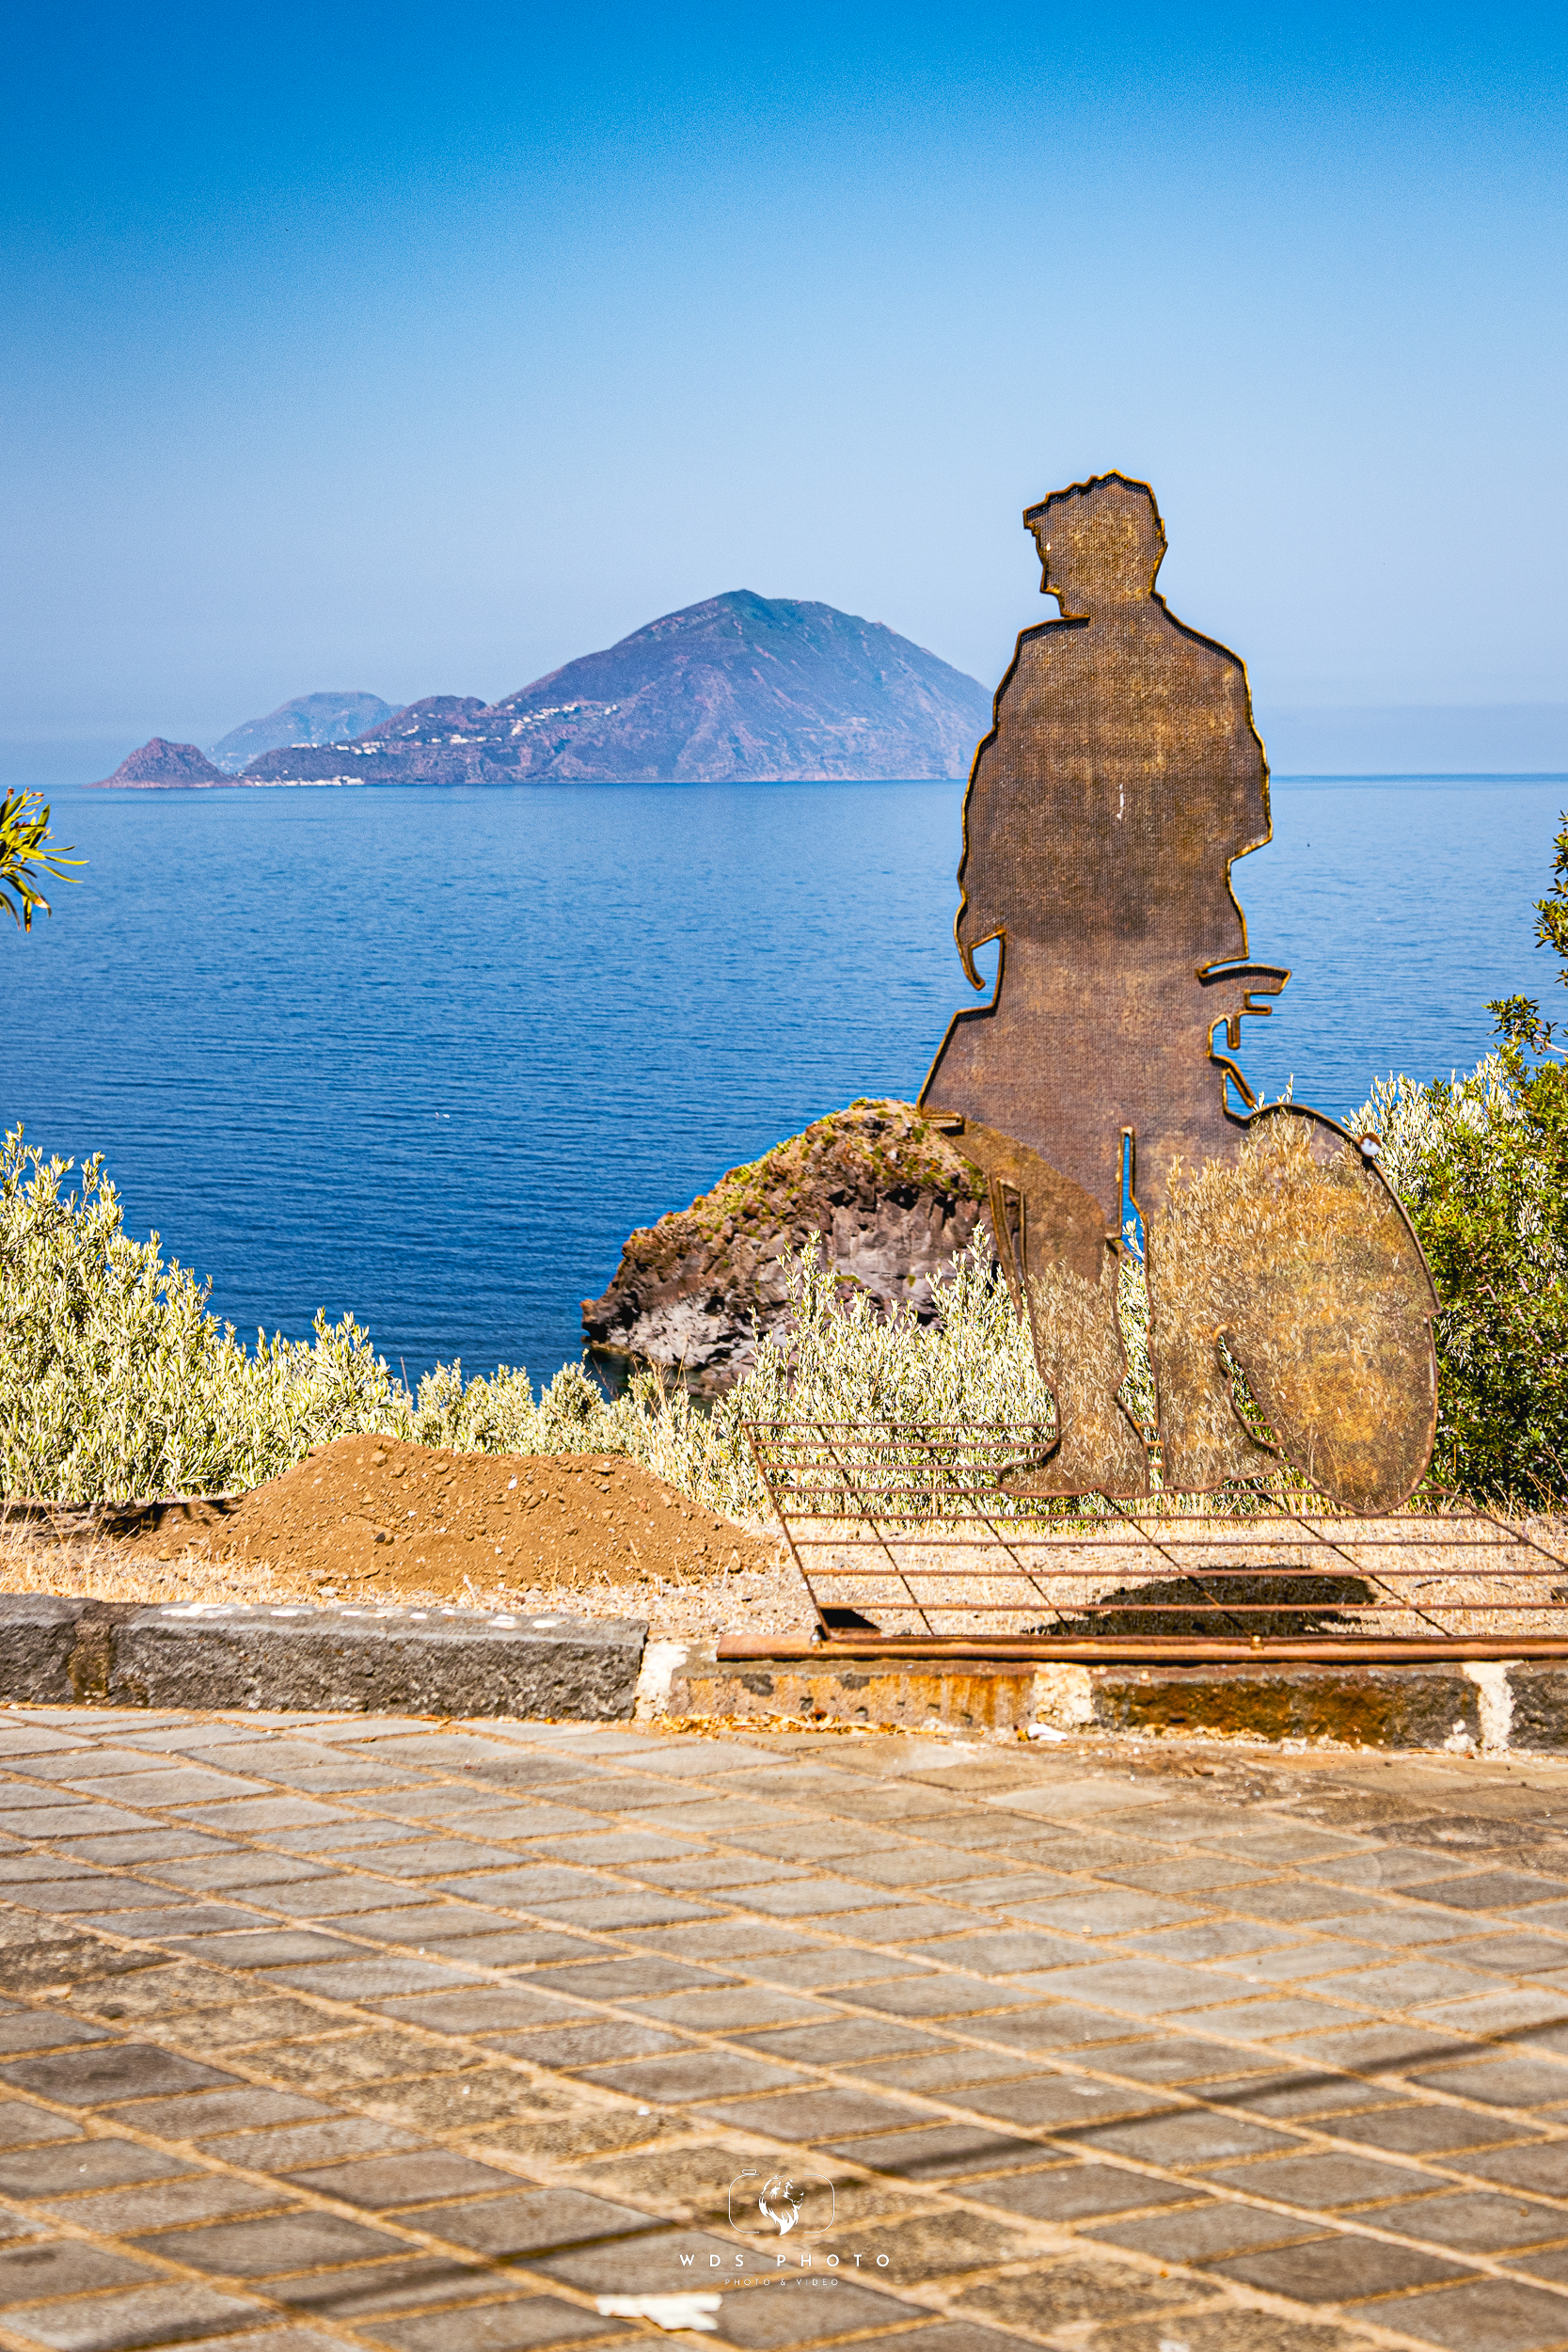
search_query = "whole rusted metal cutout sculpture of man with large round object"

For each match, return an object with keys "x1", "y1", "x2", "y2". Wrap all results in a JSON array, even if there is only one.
[{"x1": 922, "y1": 473, "x2": 1436, "y2": 1508}]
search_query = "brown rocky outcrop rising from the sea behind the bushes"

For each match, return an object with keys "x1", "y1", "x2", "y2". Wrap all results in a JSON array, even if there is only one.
[{"x1": 583, "y1": 1104, "x2": 985, "y2": 1392}]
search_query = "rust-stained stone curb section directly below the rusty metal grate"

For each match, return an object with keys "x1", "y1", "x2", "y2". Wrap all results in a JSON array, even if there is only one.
[{"x1": 660, "y1": 1645, "x2": 1568, "y2": 1755}]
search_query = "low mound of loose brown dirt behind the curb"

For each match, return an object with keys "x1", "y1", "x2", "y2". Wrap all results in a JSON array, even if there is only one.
[{"x1": 118, "y1": 1438, "x2": 776, "y2": 1602}]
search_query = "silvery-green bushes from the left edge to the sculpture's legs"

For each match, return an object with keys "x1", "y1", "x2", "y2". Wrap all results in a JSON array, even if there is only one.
[{"x1": 0, "y1": 1132, "x2": 1051, "y2": 1515}]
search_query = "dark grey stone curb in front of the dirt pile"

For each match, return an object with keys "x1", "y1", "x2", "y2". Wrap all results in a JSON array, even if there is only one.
[{"x1": 0, "y1": 1593, "x2": 646, "y2": 1722}]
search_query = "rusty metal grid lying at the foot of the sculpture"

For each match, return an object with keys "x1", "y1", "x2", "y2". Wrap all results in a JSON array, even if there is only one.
[{"x1": 726, "y1": 1421, "x2": 1568, "y2": 1661}]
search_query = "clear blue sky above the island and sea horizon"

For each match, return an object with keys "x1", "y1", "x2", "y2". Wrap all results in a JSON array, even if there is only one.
[{"x1": 0, "y1": 0, "x2": 1568, "y2": 774}]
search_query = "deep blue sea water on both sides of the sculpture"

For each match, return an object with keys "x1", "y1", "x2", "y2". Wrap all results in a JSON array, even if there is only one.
[{"x1": 0, "y1": 779, "x2": 1568, "y2": 1378}]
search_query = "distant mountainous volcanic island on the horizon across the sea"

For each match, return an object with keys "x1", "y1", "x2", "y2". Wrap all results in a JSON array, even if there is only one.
[{"x1": 103, "y1": 588, "x2": 992, "y2": 790}]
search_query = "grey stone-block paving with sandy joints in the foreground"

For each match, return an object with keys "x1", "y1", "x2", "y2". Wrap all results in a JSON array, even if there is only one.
[{"x1": 0, "y1": 1708, "x2": 1568, "y2": 2352}]
